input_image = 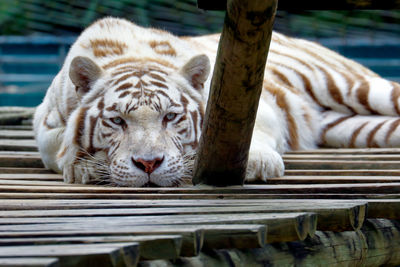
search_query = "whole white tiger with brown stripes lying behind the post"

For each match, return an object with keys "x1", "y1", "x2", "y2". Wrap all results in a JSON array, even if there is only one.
[{"x1": 34, "y1": 18, "x2": 400, "y2": 186}]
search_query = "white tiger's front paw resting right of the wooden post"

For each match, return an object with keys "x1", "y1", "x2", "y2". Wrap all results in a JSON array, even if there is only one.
[{"x1": 245, "y1": 149, "x2": 285, "y2": 182}]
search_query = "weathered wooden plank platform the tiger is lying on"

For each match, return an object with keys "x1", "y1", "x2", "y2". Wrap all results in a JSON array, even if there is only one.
[{"x1": 0, "y1": 126, "x2": 400, "y2": 266}]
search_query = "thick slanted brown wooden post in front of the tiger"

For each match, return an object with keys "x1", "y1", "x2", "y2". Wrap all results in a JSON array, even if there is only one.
[{"x1": 193, "y1": 0, "x2": 277, "y2": 186}]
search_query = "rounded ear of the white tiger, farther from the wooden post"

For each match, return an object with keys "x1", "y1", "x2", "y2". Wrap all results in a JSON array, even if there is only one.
[{"x1": 69, "y1": 56, "x2": 102, "y2": 98}]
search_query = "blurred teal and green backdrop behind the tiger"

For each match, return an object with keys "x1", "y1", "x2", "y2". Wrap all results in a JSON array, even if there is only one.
[{"x1": 0, "y1": 0, "x2": 400, "y2": 106}]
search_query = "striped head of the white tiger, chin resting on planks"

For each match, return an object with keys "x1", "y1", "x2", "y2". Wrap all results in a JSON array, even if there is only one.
[{"x1": 61, "y1": 55, "x2": 210, "y2": 187}]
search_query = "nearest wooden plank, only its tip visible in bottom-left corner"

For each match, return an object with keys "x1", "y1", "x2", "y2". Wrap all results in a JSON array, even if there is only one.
[{"x1": 0, "y1": 257, "x2": 60, "y2": 267}]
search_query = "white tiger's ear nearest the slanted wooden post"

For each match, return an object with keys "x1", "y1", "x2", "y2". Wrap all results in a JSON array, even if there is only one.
[{"x1": 180, "y1": 55, "x2": 210, "y2": 90}]
